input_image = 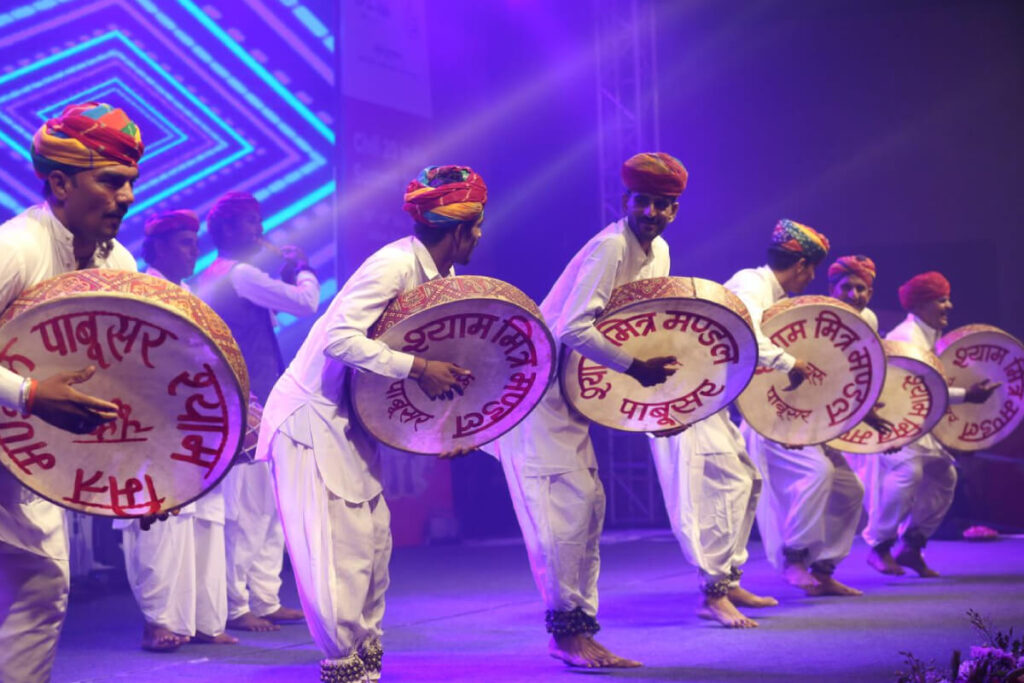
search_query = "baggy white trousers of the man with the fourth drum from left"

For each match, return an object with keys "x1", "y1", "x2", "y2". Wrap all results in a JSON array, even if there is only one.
[{"x1": 650, "y1": 414, "x2": 761, "y2": 587}]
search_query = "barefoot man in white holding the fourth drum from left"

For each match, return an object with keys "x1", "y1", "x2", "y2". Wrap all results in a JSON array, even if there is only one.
[{"x1": 650, "y1": 220, "x2": 827, "y2": 629}]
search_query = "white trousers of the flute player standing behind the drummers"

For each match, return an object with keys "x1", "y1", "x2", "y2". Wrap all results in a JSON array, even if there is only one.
[{"x1": 221, "y1": 462, "x2": 285, "y2": 620}]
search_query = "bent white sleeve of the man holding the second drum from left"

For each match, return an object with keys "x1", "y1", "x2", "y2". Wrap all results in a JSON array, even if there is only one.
[{"x1": 324, "y1": 257, "x2": 414, "y2": 379}]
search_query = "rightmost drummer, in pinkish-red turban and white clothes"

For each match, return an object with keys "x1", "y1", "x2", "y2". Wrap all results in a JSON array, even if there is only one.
[{"x1": 863, "y1": 270, "x2": 999, "y2": 578}]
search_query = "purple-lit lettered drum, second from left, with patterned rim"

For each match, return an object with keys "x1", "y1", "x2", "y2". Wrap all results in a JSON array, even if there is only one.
[{"x1": 348, "y1": 275, "x2": 555, "y2": 455}]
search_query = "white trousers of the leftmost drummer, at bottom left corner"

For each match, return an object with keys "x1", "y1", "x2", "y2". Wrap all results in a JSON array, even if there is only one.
[{"x1": 0, "y1": 542, "x2": 71, "y2": 683}]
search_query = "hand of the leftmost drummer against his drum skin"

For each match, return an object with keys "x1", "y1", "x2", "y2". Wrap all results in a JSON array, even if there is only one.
[{"x1": 32, "y1": 366, "x2": 118, "y2": 434}]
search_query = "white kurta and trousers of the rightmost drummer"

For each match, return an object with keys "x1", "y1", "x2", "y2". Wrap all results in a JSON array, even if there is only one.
[{"x1": 863, "y1": 313, "x2": 966, "y2": 548}]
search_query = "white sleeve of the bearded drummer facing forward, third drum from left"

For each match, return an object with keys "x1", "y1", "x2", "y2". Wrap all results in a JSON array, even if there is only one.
[{"x1": 558, "y1": 240, "x2": 633, "y2": 372}]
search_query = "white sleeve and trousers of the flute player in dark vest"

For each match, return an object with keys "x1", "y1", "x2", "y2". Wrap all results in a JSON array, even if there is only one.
[{"x1": 220, "y1": 263, "x2": 319, "y2": 620}]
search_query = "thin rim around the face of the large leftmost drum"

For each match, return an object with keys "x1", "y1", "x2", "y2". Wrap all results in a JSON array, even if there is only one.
[{"x1": 0, "y1": 288, "x2": 249, "y2": 519}]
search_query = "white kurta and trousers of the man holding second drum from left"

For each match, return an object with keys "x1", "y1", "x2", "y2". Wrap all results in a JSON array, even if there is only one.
[{"x1": 256, "y1": 237, "x2": 444, "y2": 658}]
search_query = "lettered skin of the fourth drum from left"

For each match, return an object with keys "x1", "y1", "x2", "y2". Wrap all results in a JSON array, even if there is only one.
[{"x1": 736, "y1": 295, "x2": 886, "y2": 445}]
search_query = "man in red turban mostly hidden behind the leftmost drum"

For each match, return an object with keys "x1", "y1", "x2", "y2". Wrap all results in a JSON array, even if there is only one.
[{"x1": 114, "y1": 211, "x2": 238, "y2": 652}]
